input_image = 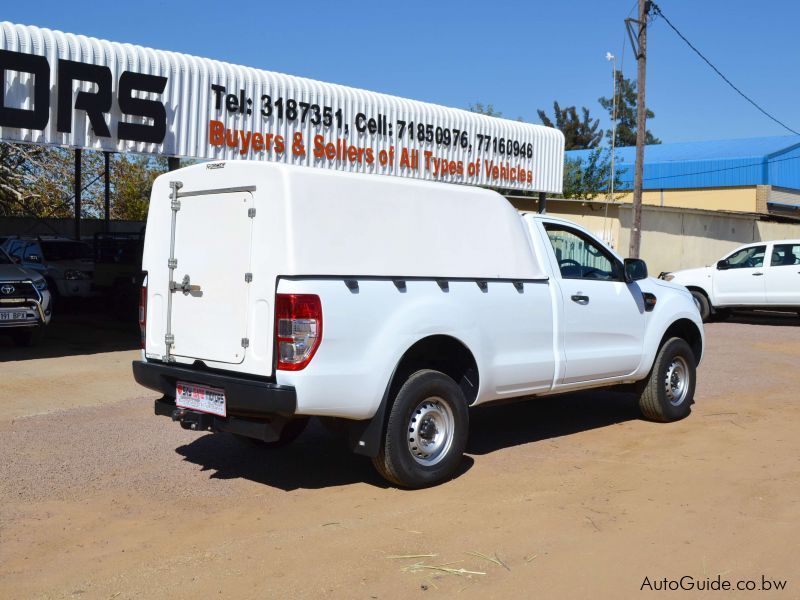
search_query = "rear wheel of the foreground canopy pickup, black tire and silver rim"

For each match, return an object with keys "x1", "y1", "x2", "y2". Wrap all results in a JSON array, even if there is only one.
[{"x1": 372, "y1": 369, "x2": 469, "y2": 488}]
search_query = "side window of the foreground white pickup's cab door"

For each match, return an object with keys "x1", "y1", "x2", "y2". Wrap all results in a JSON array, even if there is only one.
[{"x1": 544, "y1": 223, "x2": 620, "y2": 281}]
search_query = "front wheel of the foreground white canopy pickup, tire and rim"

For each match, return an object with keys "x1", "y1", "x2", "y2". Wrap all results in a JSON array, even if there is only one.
[{"x1": 639, "y1": 338, "x2": 697, "y2": 423}]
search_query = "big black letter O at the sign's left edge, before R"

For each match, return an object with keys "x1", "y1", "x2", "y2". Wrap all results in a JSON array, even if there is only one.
[{"x1": 0, "y1": 50, "x2": 50, "y2": 129}]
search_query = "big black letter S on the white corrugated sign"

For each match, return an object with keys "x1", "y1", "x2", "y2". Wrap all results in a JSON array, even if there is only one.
[{"x1": 117, "y1": 71, "x2": 167, "y2": 144}]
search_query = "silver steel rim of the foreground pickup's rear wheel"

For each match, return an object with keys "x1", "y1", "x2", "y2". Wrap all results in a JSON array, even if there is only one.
[{"x1": 406, "y1": 396, "x2": 455, "y2": 467}]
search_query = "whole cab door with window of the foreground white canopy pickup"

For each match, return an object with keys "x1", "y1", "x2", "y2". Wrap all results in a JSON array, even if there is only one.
[{"x1": 543, "y1": 222, "x2": 646, "y2": 384}]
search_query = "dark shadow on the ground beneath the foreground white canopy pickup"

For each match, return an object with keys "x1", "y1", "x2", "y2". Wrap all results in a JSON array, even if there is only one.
[{"x1": 175, "y1": 392, "x2": 639, "y2": 491}]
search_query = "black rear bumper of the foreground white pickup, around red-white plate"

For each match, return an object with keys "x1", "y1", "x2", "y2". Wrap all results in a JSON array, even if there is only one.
[{"x1": 133, "y1": 360, "x2": 297, "y2": 419}]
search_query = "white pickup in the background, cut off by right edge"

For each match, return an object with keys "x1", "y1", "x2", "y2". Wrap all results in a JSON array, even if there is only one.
[{"x1": 661, "y1": 240, "x2": 800, "y2": 321}]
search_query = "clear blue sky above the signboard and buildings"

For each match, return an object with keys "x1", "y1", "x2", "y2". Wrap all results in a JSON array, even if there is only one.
[{"x1": 0, "y1": 0, "x2": 800, "y2": 142}]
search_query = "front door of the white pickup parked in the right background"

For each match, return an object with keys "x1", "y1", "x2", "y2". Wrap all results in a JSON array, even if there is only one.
[{"x1": 713, "y1": 244, "x2": 767, "y2": 306}]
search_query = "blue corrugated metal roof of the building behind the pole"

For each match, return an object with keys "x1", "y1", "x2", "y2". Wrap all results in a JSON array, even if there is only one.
[{"x1": 565, "y1": 135, "x2": 800, "y2": 189}]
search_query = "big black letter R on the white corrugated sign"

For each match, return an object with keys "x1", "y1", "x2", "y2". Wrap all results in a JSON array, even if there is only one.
[{"x1": 56, "y1": 59, "x2": 111, "y2": 137}]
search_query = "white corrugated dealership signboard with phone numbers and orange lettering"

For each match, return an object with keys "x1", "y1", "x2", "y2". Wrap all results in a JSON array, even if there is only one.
[{"x1": 0, "y1": 23, "x2": 564, "y2": 193}]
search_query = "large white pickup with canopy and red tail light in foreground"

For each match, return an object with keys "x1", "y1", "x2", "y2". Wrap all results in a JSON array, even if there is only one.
[{"x1": 133, "y1": 161, "x2": 704, "y2": 487}]
